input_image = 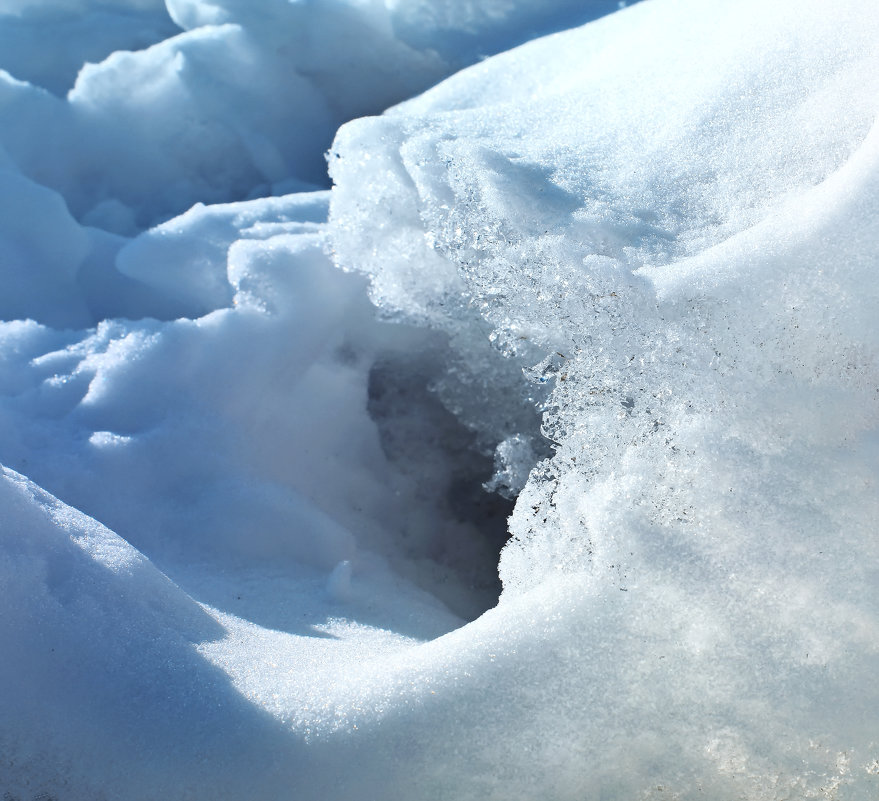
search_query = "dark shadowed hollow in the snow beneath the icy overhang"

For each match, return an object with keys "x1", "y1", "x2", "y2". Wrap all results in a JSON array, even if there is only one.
[{"x1": 367, "y1": 353, "x2": 514, "y2": 620}]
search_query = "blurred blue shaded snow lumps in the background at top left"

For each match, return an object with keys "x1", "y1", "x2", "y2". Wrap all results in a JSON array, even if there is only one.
[{"x1": 0, "y1": 0, "x2": 614, "y2": 235}]
